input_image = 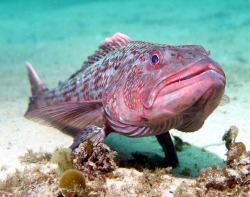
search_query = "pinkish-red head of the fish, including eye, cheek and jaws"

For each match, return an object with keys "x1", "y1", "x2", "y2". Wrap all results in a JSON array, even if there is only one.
[{"x1": 102, "y1": 41, "x2": 225, "y2": 131}]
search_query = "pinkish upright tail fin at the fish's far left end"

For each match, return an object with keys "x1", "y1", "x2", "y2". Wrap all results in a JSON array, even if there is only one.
[{"x1": 24, "y1": 62, "x2": 48, "y2": 116}]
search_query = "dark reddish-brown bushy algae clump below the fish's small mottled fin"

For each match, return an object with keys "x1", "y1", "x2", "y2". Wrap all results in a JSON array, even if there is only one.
[{"x1": 71, "y1": 139, "x2": 117, "y2": 180}]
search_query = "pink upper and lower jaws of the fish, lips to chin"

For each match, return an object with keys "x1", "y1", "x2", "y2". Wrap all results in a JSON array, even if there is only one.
[{"x1": 145, "y1": 57, "x2": 226, "y2": 124}]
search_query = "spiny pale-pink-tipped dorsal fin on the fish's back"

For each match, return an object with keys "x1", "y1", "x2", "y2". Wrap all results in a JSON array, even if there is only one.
[{"x1": 70, "y1": 32, "x2": 132, "y2": 78}]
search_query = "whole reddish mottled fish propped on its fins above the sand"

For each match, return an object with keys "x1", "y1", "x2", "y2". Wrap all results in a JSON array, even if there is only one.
[{"x1": 24, "y1": 33, "x2": 227, "y2": 167}]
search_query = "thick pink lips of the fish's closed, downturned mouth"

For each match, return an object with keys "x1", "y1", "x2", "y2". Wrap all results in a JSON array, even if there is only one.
[{"x1": 143, "y1": 57, "x2": 225, "y2": 108}]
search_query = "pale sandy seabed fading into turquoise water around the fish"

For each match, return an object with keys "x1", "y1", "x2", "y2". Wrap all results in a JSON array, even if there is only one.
[{"x1": 0, "y1": 0, "x2": 250, "y2": 195}]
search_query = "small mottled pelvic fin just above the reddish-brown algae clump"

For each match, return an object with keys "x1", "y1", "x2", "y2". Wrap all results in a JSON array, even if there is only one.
[{"x1": 70, "y1": 125, "x2": 109, "y2": 150}]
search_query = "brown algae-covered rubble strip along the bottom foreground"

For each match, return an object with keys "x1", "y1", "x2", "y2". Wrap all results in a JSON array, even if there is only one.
[{"x1": 0, "y1": 127, "x2": 250, "y2": 197}]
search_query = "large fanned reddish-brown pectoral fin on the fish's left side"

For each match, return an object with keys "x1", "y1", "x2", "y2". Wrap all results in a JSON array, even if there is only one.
[{"x1": 25, "y1": 100, "x2": 103, "y2": 136}]
